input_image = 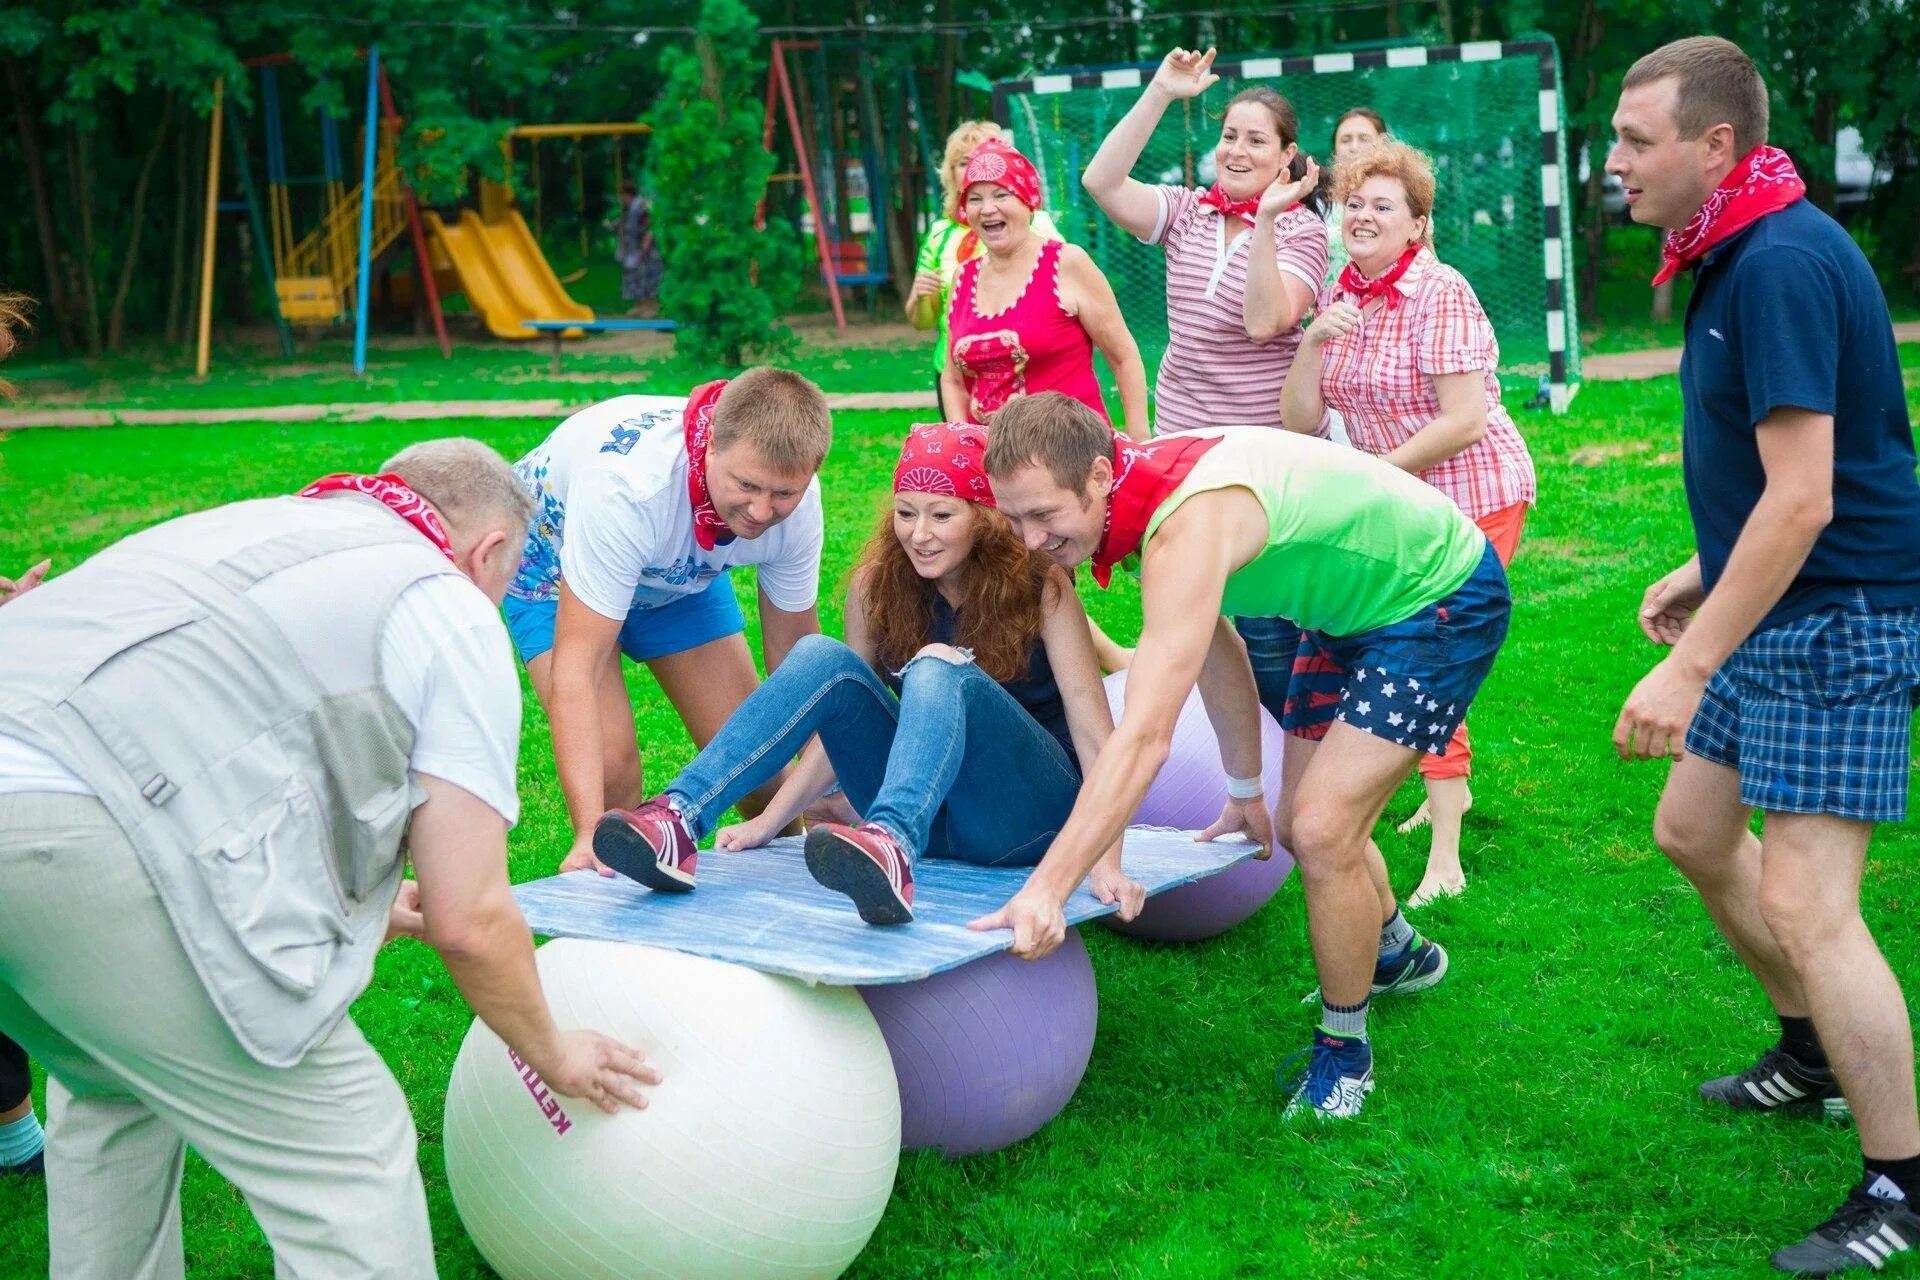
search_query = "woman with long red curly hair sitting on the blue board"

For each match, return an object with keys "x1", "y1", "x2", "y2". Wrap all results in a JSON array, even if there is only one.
[{"x1": 593, "y1": 422, "x2": 1142, "y2": 925}]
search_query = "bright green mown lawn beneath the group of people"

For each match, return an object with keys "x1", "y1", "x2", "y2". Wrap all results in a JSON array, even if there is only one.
[{"x1": 0, "y1": 362, "x2": 1920, "y2": 1280}]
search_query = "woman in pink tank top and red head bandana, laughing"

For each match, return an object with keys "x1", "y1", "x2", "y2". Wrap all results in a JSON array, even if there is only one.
[{"x1": 941, "y1": 138, "x2": 1146, "y2": 439}]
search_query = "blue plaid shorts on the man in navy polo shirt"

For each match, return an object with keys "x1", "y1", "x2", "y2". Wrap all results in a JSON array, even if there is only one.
[{"x1": 1686, "y1": 591, "x2": 1920, "y2": 821}]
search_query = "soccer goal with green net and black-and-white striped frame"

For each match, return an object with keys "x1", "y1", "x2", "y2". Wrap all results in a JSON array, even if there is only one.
[{"x1": 995, "y1": 38, "x2": 1580, "y2": 413}]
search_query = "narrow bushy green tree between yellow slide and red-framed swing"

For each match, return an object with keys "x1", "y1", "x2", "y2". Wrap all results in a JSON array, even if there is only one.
[{"x1": 647, "y1": 0, "x2": 797, "y2": 368}]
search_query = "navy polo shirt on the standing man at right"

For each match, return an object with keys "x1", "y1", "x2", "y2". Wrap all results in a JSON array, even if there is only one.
[{"x1": 1680, "y1": 200, "x2": 1920, "y2": 628}]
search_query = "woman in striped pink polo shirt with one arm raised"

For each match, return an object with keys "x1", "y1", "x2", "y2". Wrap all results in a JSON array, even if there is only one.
[{"x1": 1081, "y1": 48, "x2": 1327, "y2": 436}]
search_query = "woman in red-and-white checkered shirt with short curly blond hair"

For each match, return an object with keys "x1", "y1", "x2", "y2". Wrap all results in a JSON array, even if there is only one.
[{"x1": 1281, "y1": 138, "x2": 1536, "y2": 906}]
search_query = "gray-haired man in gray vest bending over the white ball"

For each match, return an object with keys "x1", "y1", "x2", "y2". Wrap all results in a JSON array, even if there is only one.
[{"x1": 0, "y1": 439, "x2": 659, "y2": 1280}]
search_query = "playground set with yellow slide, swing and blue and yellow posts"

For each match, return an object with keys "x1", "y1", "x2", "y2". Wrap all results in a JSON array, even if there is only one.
[{"x1": 194, "y1": 48, "x2": 637, "y2": 378}]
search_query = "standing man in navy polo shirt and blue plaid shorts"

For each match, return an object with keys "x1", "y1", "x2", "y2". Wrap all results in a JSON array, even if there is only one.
[{"x1": 1607, "y1": 36, "x2": 1920, "y2": 1276}]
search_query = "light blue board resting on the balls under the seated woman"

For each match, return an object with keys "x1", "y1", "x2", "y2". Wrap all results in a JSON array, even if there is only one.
[{"x1": 513, "y1": 827, "x2": 1254, "y2": 986}]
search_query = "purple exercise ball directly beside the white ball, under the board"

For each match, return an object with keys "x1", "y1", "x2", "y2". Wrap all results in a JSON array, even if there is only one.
[{"x1": 860, "y1": 929, "x2": 1100, "y2": 1157}]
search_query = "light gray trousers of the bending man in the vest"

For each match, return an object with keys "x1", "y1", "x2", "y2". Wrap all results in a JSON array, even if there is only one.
[{"x1": 0, "y1": 794, "x2": 434, "y2": 1280}]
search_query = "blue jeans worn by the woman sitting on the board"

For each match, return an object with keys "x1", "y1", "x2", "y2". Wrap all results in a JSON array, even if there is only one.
[{"x1": 666, "y1": 635, "x2": 1081, "y2": 867}]
